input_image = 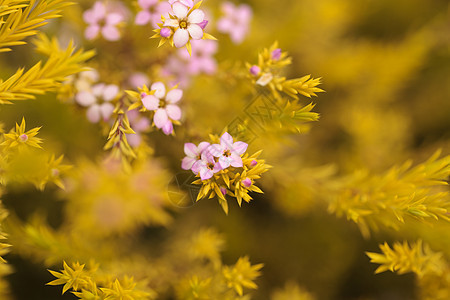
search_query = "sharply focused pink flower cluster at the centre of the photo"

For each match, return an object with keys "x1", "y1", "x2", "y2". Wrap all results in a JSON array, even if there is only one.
[{"x1": 181, "y1": 132, "x2": 248, "y2": 180}]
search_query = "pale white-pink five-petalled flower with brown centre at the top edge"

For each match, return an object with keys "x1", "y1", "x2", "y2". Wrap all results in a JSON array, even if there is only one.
[{"x1": 164, "y1": 1, "x2": 205, "y2": 48}]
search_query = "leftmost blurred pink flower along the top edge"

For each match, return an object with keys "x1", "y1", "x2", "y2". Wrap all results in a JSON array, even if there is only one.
[{"x1": 83, "y1": 1, "x2": 124, "y2": 41}]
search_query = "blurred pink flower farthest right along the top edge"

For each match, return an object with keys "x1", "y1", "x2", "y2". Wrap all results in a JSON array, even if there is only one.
[{"x1": 217, "y1": 2, "x2": 252, "y2": 44}]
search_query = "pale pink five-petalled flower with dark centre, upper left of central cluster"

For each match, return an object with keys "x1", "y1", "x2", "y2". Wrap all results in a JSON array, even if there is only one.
[{"x1": 142, "y1": 82, "x2": 183, "y2": 134}]
